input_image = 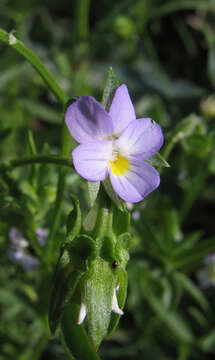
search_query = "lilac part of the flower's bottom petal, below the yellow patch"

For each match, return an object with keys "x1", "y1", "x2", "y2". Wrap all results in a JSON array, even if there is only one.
[{"x1": 110, "y1": 159, "x2": 160, "y2": 203}]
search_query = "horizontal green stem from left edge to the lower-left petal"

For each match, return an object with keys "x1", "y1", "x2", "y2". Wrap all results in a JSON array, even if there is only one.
[{"x1": 0, "y1": 155, "x2": 73, "y2": 172}]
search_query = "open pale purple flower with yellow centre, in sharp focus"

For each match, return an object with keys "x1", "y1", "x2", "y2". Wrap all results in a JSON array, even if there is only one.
[{"x1": 65, "y1": 84, "x2": 163, "y2": 203}]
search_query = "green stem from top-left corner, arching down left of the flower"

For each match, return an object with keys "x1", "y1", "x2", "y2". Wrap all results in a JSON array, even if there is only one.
[{"x1": 0, "y1": 29, "x2": 70, "y2": 257}]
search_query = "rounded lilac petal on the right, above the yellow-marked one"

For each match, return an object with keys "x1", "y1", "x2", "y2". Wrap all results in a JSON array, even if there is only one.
[{"x1": 115, "y1": 118, "x2": 163, "y2": 160}]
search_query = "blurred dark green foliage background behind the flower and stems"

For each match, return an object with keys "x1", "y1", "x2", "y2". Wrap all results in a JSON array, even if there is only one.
[{"x1": 0, "y1": 0, "x2": 215, "y2": 360}]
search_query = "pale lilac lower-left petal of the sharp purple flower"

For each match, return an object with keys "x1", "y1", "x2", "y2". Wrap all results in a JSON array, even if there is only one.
[{"x1": 72, "y1": 141, "x2": 112, "y2": 181}]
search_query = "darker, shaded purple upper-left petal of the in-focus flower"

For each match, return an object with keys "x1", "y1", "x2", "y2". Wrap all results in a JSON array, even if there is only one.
[{"x1": 65, "y1": 96, "x2": 113, "y2": 143}]
